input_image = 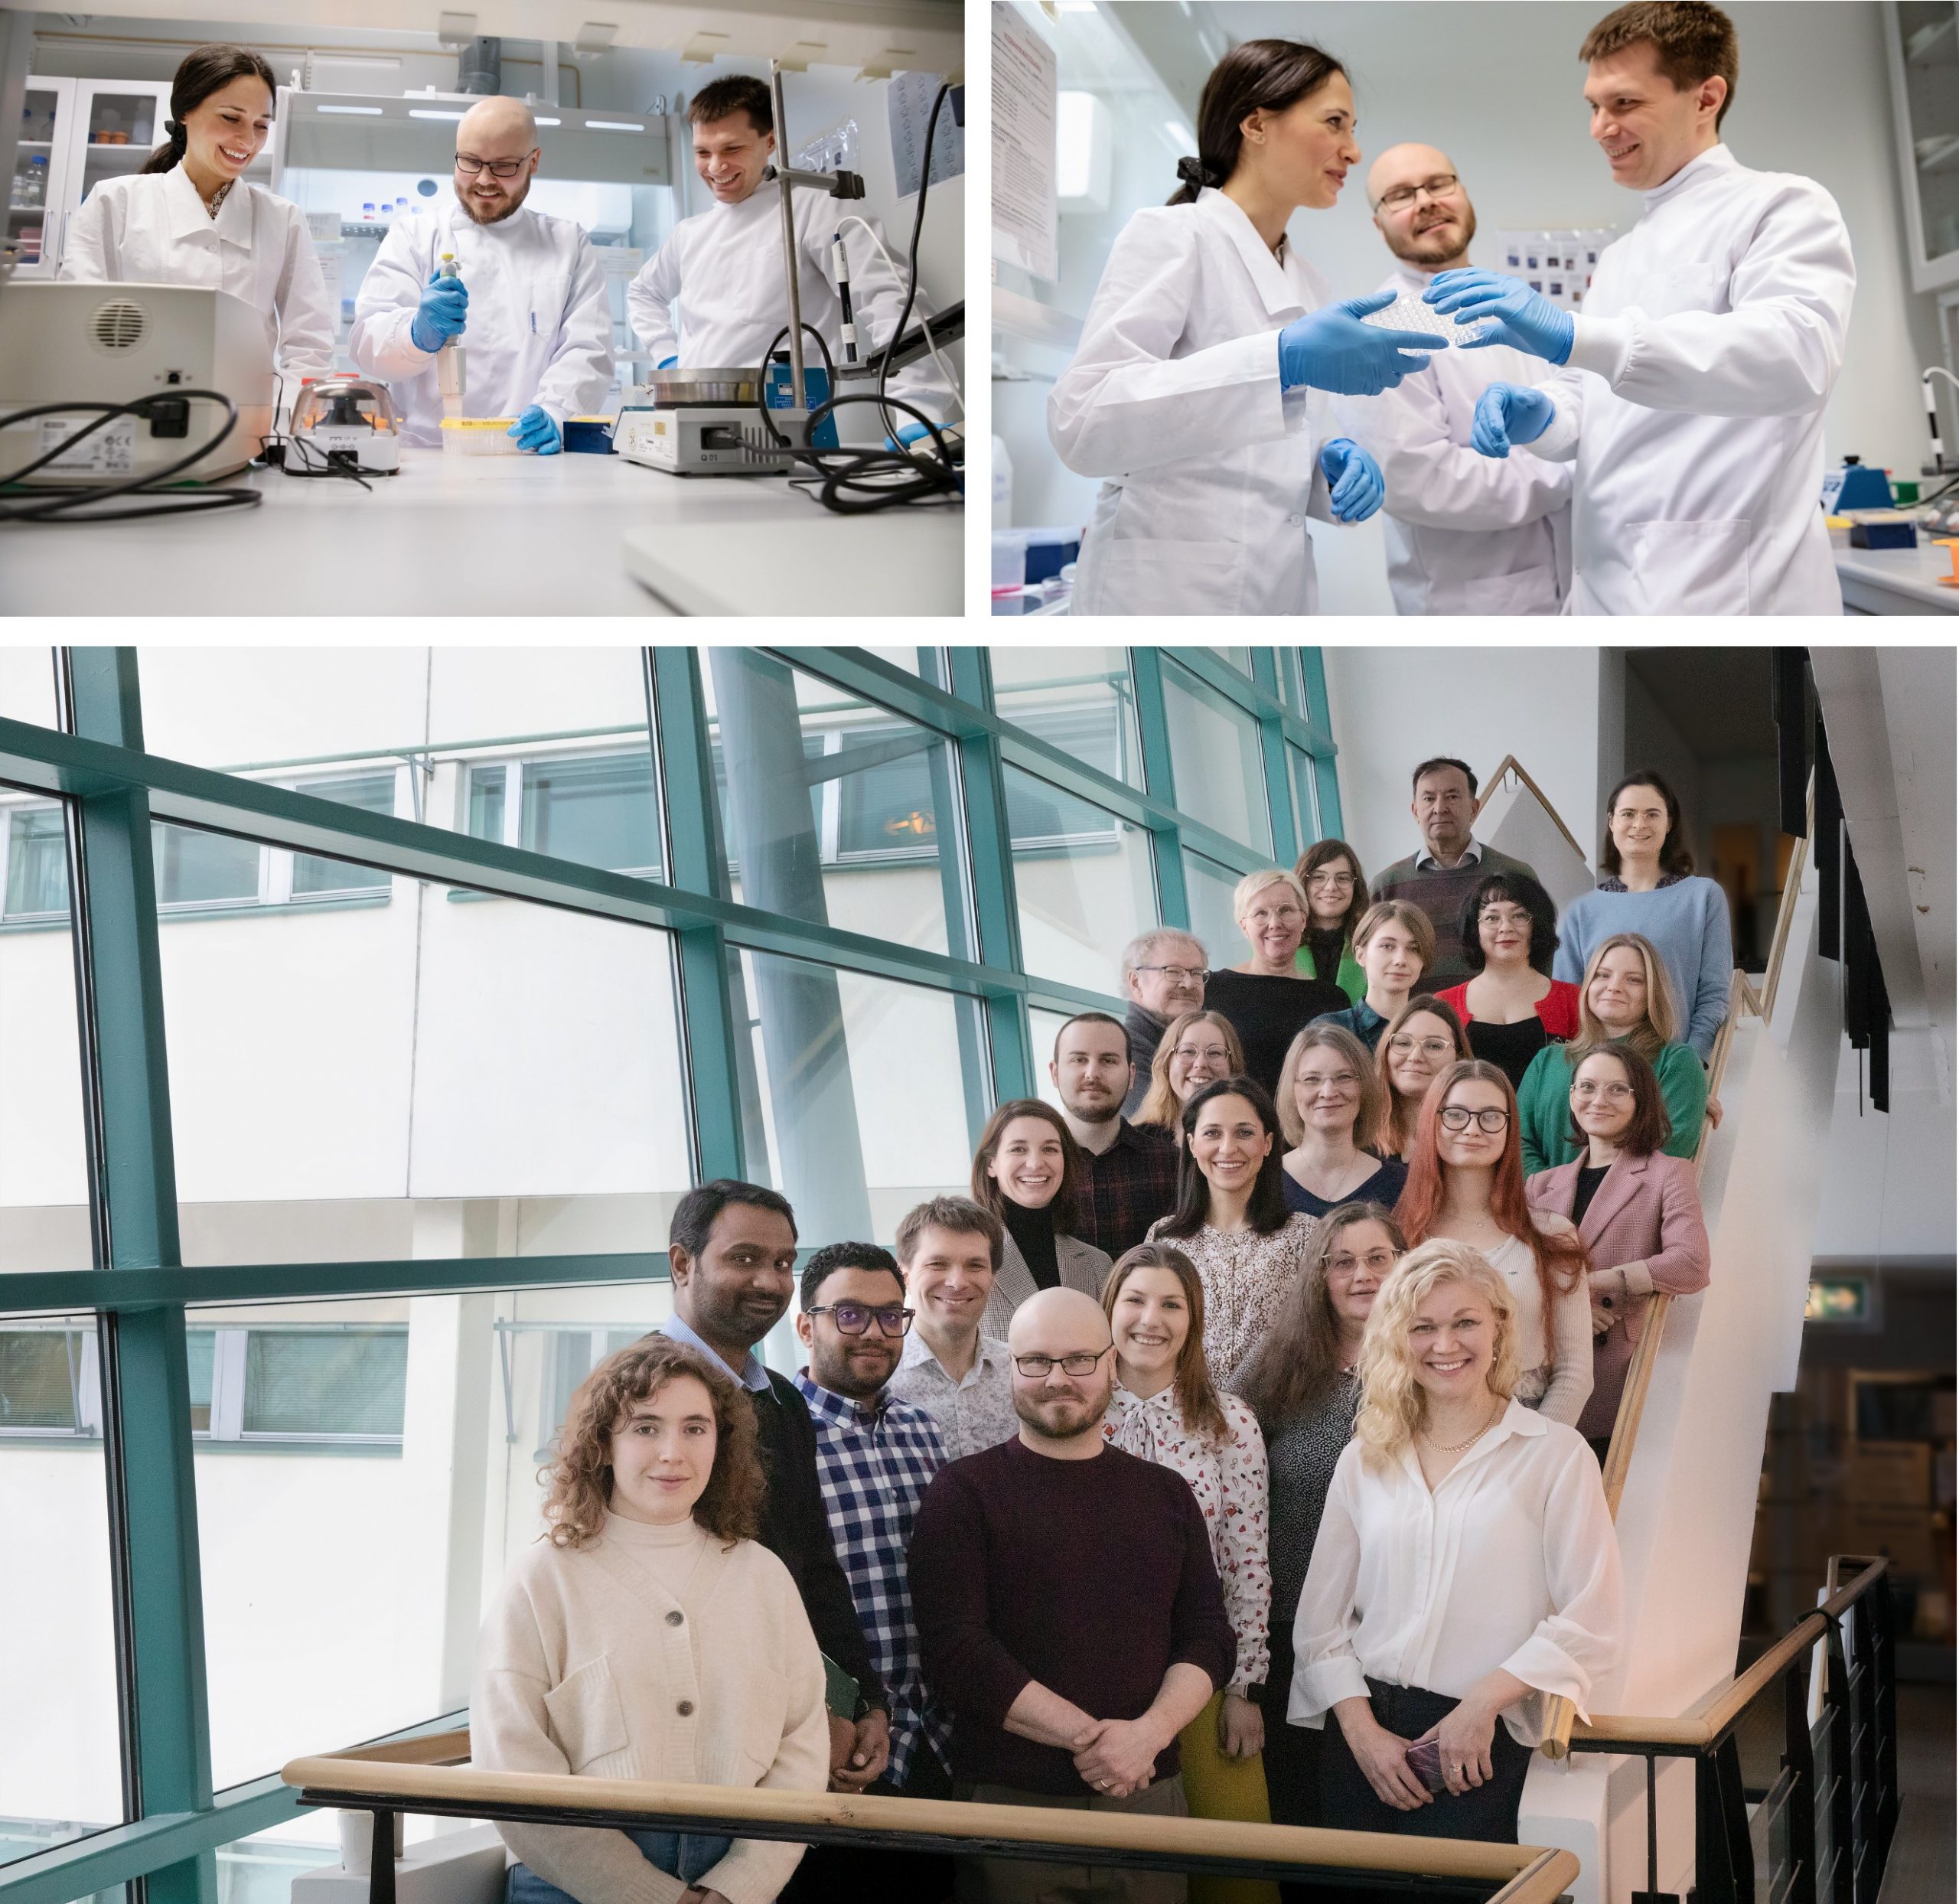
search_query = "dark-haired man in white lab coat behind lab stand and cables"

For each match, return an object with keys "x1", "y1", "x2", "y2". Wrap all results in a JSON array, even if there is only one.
[{"x1": 625, "y1": 74, "x2": 950, "y2": 417}]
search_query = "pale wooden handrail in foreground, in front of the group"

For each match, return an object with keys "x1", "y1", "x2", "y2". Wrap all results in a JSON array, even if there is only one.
[{"x1": 280, "y1": 1733, "x2": 1551, "y2": 1880}]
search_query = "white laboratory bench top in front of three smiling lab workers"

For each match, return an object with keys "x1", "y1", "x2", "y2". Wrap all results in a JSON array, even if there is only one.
[{"x1": 0, "y1": 448, "x2": 966, "y2": 615}]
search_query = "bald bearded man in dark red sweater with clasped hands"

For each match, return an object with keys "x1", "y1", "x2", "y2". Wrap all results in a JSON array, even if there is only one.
[{"x1": 911, "y1": 1287, "x2": 1236, "y2": 1904}]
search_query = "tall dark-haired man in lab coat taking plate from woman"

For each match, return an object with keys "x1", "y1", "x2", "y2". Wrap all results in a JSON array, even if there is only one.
[{"x1": 1428, "y1": 0, "x2": 1857, "y2": 615}]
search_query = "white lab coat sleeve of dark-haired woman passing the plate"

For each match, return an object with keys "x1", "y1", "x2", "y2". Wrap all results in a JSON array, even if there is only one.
[{"x1": 1048, "y1": 207, "x2": 1325, "y2": 490}]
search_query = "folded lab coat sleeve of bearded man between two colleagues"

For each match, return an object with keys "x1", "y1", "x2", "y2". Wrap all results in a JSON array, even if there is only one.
[{"x1": 1338, "y1": 370, "x2": 1571, "y2": 529}]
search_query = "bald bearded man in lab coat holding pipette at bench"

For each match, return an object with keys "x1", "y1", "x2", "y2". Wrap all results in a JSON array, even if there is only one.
[{"x1": 350, "y1": 98, "x2": 613, "y2": 456}]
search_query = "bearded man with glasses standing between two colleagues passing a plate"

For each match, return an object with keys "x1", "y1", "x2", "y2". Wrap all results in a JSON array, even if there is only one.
[{"x1": 1336, "y1": 145, "x2": 1571, "y2": 615}]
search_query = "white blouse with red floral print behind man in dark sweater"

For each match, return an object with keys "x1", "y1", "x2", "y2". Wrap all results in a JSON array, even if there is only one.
[{"x1": 1103, "y1": 1383, "x2": 1271, "y2": 1690}]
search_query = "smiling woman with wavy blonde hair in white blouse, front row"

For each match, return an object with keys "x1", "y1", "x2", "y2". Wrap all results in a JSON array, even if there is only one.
[{"x1": 1289, "y1": 1238, "x2": 1624, "y2": 1844}]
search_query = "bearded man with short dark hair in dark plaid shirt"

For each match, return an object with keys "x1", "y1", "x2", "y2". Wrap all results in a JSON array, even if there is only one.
[{"x1": 1048, "y1": 1011, "x2": 1179, "y2": 1260}]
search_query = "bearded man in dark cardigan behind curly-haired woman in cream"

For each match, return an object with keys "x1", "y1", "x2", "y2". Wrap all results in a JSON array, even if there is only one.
[{"x1": 658, "y1": 1177, "x2": 891, "y2": 1791}]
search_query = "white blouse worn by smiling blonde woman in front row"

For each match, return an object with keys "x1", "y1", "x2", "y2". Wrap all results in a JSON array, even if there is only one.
[{"x1": 1287, "y1": 1400, "x2": 1624, "y2": 1746}]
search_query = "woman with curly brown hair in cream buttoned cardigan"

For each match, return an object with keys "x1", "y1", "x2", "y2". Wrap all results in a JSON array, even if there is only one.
[{"x1": 481, "y1": 1336, "x2": 830, "y2": 1904}]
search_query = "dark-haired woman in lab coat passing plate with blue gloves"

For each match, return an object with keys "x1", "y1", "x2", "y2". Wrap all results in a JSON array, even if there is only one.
[{"x1": 1048, "y1": 39, "x2": 1436, "y2": 615}]
